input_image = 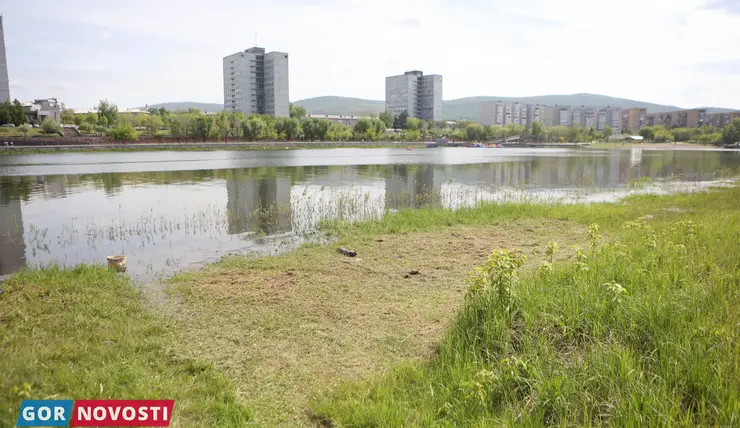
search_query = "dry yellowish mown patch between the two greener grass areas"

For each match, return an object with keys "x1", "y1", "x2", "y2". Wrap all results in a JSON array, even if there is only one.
[{"x1": 169, "y1": 220, "x2": 585, "y2": 426}]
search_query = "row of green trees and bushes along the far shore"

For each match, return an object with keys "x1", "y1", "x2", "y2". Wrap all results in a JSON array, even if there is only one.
[{"x1": 55, "y1": 100, "x2": 740, "y2": 144}]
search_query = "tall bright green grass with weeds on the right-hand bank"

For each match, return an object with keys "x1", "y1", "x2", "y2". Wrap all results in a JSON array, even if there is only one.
[{"x1": 312, "y1": 189, "x2": 740, "y2": 427}]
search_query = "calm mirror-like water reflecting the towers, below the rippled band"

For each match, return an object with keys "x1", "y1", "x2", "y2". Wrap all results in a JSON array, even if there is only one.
[{"x1": 0, "y1": 149, "x2": 740, "y2": 280}]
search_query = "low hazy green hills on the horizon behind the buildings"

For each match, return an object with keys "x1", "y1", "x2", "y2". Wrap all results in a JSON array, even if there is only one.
[{"x1": 147, "y1": 94, "x2": 735, "y2": 120}]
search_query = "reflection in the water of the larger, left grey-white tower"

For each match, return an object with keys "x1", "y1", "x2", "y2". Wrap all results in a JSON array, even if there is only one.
[{"x1": 226, "y1": 170, "x2": 293, "y2": 235}]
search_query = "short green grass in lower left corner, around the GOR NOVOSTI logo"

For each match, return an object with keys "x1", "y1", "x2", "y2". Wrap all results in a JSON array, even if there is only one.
[{"x1": 0, "y1": 266, "x2": 251, "y2": 426}]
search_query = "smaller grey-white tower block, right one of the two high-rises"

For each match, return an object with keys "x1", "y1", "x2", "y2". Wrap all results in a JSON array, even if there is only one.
[{"x1": 385, "y1": 70, "x2": 442, "y2": 121}]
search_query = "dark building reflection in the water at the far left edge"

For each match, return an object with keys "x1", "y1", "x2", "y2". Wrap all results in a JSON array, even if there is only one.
[{"x1": 0, "y1": 198, "x2": 26, "y2": 275}]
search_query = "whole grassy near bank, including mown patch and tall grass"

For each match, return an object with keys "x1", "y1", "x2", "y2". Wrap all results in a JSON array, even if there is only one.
[{"x1": 0, "y1": 188, "x2": 740, "y2": 426}]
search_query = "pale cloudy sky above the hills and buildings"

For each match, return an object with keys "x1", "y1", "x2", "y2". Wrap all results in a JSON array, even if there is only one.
[{"x1": 0, "y1": 0, "x2": 740, "y2": 109}]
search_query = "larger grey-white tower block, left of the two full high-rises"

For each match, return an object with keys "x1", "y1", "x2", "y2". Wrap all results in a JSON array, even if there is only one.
[{"x1": 223, "y1": 47, "x2": 290, "y2": 117}]
